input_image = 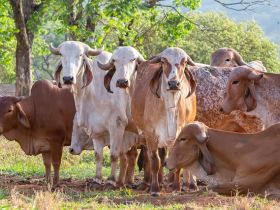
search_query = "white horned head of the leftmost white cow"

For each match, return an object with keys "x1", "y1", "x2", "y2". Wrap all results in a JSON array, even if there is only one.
[{"x1": 50, "y1": 41, "x2": 102, "y2": 87}]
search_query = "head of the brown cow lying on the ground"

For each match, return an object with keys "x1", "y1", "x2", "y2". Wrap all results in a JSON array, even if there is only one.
[{"x1": 165, "y1": 122, "x2": 214, "y2": 175}]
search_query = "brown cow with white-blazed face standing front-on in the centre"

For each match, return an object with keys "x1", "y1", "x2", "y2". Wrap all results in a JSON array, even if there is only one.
[{"x1": 131, "y1": 47, "x2": 196, "y2": 196}]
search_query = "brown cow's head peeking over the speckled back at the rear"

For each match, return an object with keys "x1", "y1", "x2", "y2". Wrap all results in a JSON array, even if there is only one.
[{"x1": 210, "y1": 48, "x2": 246, "y2": 67}]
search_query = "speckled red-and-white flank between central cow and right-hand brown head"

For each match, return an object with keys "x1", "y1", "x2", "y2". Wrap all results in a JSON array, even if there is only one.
[{"x1": 191, "y1": 67, "x2": 262, "y2": 133}]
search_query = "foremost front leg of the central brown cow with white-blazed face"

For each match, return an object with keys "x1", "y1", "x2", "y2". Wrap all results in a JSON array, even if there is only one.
[{"x1": 147, "y1": 139, "x2": 160, "y2": 196}]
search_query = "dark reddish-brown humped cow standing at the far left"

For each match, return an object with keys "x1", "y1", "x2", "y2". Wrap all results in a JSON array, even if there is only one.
[{"x1": 0, "y1": 80, "x2": 92, "y2": 187}]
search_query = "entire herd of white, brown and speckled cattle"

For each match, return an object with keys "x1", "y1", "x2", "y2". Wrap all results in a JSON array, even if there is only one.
[{"x1": 0, "y1": 41, "x2": 280, "y2": 196}]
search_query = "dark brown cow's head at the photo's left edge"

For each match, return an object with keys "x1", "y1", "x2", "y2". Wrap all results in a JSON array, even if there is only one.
[{"x1": 0, "y1": 97, "x2": 30, "y2": 134}]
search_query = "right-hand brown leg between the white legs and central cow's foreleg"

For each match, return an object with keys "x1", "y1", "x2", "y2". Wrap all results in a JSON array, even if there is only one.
[{"x1": 125, "y1": 146, "x2": 138, "y2": 185}]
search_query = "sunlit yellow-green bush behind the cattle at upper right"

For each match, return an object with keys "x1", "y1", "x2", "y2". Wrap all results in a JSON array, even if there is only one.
[{"x1": 177, "y1": 13, "x2": 280, "y2": 72}]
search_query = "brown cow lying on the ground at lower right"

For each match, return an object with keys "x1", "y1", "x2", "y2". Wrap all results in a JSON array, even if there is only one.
[{"x1": 166, "y1": 122, "x2": 280, "y2": 195}]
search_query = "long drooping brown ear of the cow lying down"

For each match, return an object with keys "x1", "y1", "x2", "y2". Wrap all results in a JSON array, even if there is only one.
[{"x1": 198, "y1": 142, "x2": 215, "y2": 175}]
